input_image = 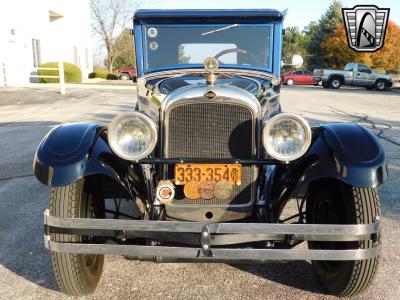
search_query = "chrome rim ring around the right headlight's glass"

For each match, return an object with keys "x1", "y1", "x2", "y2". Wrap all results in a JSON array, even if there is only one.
[{"x1": 262, "y1": 113, "x2": 312, "y2": 162}]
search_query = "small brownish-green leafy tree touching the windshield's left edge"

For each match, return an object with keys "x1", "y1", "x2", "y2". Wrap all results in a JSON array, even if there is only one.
[{"x1": 113, "y1": 29, "x2": 135, "y2": 69}]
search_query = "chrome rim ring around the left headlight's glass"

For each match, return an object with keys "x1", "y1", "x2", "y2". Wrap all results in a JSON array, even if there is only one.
[{"x1": 107, "y1": 111, "x2": 158, "y2": 161}]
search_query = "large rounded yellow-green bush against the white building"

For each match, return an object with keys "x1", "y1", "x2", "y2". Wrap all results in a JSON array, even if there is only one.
[{"x1": 38, "y1": 62, "x2": 82, "y2": 83}]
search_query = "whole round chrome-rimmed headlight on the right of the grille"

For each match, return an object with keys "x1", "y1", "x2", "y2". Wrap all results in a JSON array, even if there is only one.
[{"x1": 262, "y1": 113, "x2": 311, "y2": 161}]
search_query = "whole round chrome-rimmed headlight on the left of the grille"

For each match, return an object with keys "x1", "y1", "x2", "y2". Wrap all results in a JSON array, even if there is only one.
[{"x1": 108, "y1": 112, "x2": 157, "y2": 160}]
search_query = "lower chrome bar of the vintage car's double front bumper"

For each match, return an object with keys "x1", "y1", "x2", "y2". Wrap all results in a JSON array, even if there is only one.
[{"x1": 45, "y1": 236, "x2": 380, "y2": 262}]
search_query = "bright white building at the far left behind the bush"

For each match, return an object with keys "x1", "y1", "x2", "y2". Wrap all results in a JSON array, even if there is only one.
[{"x1": 0, "y1": 0, "x2": 93, "y2": 86}]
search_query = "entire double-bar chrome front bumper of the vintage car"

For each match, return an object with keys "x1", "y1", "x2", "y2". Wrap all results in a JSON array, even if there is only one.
[{"x1": 44, "y1": 210, "x2": 380, "y2": 262}]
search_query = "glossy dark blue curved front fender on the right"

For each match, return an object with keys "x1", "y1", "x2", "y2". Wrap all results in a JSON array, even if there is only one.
[{"x1": 268, "y1": 123, "x2": 388, "y2": 219}]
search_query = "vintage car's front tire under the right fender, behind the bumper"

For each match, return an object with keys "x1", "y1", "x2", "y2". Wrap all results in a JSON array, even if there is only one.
[{"x1": 307, "y1": 181, "x2": 380, "y2": 297}]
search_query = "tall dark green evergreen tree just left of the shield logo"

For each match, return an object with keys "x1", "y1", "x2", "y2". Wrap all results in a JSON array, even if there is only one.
[{"x1": 305, "y1": 0, "x2": 343, "y2": 68}]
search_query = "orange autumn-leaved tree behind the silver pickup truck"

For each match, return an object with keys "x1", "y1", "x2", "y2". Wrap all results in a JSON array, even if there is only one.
[{"x1": 321, "y1": 21, "x2": 400, "y2": 73}]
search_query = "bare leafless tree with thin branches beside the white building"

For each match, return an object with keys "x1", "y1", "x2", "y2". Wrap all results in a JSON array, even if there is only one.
[{"x1": 90, "y1": 0, "x2": 133, "y2": 73}]
